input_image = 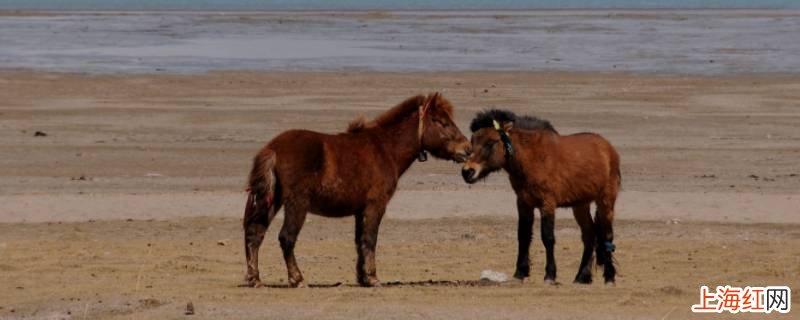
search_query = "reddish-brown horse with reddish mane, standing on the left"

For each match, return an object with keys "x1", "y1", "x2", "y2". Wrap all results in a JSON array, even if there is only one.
[{"x1": 244, "y1": 93, "x2": 470, "y2": 287}]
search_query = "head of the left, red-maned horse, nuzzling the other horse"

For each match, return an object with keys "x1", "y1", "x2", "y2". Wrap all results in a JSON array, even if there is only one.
[{"x1": 419, "y1": 92, "x2": 470, "y2": 162}]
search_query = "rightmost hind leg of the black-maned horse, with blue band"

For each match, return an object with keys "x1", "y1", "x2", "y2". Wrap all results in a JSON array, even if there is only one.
[{"x1": 595, "y1": 198, "x2": 617, "y2": 284}]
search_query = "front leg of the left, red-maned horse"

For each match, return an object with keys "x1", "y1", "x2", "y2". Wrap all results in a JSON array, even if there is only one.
[{"x1": 355, "y1": 204, "x2": 386, "y2": 287}]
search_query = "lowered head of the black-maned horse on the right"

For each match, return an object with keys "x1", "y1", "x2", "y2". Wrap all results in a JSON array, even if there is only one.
[{"x1": 461, "y1": 114, "x2": 514, "y2": 184}]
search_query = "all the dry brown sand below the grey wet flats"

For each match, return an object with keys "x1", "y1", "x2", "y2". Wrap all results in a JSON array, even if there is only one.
[{"x1": 0, "y1": 71, "x2": 800, "y2": 319}]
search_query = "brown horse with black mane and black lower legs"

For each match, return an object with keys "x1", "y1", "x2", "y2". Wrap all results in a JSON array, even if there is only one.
[{"x1": 461, "y1": 110, "x2": 621, "y2": 284}]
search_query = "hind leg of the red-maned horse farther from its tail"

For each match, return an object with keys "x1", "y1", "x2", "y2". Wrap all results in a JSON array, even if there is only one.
[{"x1": 278, "y1": 203, "x2": 307, "y2": 288}]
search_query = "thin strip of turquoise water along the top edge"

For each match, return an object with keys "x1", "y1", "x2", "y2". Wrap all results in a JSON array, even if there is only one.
[{"x1": 0, "y1": 0, "x2": 800, "y2": 11}]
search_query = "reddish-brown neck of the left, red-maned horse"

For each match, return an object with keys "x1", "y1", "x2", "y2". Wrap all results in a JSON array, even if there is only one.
[{"x1": 378, "y1": 116, "x2": 421, "y2": 177}]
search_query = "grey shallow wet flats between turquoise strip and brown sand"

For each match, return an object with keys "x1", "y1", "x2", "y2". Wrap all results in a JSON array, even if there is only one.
[{"x1": 0, "y1": 10, "x2": 800, "y2": 74}]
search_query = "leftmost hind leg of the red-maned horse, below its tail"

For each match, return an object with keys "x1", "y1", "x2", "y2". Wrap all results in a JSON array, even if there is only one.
[{"x1": 243, "y1": 193, "x2": 280, "y2": 287}]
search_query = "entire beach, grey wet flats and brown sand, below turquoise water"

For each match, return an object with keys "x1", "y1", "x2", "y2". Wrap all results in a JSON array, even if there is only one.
[{"x1": 0, "y1": 1, "x2": 800, "y2": 319}]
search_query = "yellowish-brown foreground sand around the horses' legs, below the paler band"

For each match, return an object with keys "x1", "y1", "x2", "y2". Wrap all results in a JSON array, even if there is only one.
[{"x1": 0, "y1": 217, "x2": 800, "y2": 319}]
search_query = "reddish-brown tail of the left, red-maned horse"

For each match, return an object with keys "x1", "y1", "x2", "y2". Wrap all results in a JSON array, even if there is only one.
[{"x1": 244, "y1": 149, "x2": 278, "y2": 227}]
